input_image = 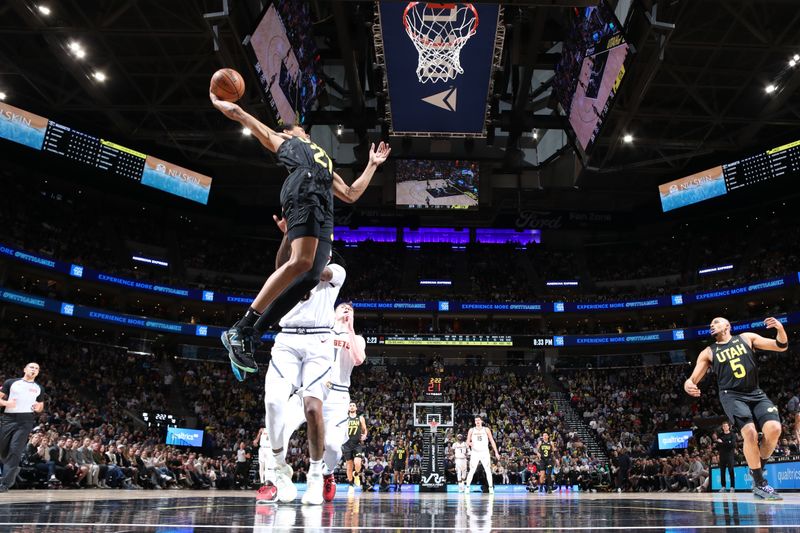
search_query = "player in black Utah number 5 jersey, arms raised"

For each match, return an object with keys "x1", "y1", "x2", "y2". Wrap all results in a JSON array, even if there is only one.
[{"x1": 683, "y1": 317, "x2": 789, "y2": 500}]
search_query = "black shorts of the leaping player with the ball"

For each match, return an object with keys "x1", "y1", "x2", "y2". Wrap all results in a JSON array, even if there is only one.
[{"x1": 281, "y1": 168, "x2": 333, "y2": 242}]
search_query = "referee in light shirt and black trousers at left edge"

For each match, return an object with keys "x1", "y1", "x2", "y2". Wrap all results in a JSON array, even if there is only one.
[{"x1": 0, "y1": 363, "x2": 44, "y2": 492}]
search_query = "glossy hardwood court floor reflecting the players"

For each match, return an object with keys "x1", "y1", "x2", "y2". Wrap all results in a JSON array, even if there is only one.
[{"x1": 0, "y1": 487, "x2": 800, "y2": 533}]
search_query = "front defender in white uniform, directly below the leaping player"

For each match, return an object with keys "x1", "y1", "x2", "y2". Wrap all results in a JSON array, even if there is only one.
[{"x1": 264, "y1": 218, "x2": 346, "y2": 505}]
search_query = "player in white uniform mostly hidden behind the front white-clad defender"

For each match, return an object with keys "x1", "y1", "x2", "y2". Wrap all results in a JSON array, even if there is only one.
[{"x1": 284, "y1": 302, "x2": 367, "y2": 501}]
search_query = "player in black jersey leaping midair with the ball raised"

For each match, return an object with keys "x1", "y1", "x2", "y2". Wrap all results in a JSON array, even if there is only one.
[{"x1": 209, "y1": 91, "x2": 391, "y2": 372}]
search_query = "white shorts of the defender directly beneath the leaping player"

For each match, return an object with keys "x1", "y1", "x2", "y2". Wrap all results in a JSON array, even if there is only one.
[{"x1": 264, "y1": 333, "x2": 334, "y2": 402}]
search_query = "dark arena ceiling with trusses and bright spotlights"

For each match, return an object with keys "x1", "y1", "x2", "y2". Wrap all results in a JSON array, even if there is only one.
[{"x1": 0, "y1": 0, "x2": 800, "y2": 210}]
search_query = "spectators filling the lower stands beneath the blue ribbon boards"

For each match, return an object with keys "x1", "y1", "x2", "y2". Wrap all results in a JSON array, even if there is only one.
[{"x1": 12, "y1": 324, "x2": 800, "y2": 491}]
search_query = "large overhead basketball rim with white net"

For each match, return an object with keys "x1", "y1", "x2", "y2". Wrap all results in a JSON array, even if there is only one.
[{"x1": 403, "y1": 2, "x2": 478, "y2": 83}]
